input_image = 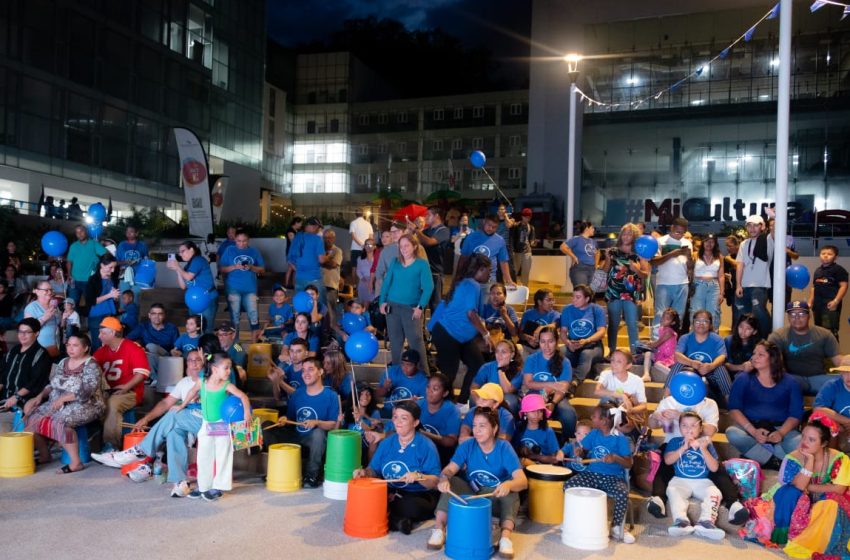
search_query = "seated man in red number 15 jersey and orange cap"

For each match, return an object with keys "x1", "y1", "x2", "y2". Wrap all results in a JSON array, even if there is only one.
[{"x1": 93, "y1": 317, "x2": 150, "y2": 452}]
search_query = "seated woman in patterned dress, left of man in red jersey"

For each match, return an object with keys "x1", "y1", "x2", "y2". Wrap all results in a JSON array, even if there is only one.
[{"x1": 24, "y1": 334, "x2": 106, "y2": 474}]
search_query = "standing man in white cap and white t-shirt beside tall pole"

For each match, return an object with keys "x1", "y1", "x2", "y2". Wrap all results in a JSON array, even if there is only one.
[{"x1": 735, "y1": 215, "x2": 773, "y2": 337}]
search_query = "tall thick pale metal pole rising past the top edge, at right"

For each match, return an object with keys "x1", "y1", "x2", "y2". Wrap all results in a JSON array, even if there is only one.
[{"x1": 773, "y1": 0, "x2": 793, "y2": 329}]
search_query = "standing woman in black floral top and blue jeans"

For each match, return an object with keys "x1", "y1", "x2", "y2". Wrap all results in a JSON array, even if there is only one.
[{"x1": 603, "y1": 224, "x2": 649, "y2": 352}]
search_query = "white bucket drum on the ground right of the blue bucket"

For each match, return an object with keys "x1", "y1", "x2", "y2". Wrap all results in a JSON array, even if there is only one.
[{"x1": 561, "y1": 488, "x2": 608, "y2": 550}]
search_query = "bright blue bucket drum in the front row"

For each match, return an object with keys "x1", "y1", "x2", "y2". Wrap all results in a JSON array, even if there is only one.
[{"x1": 446, "y1": 496, "x2": 493, "y2": 560}]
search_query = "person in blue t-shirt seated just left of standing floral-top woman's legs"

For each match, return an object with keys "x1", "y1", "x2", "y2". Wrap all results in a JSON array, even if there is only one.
[{"x1": 561, "y1": 284, "x2": 608, "y2": 387}]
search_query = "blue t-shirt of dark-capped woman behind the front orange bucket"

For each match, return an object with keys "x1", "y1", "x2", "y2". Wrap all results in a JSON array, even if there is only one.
[{"x1": 369, "y1": 432, "x2": 441, "y2": 492}]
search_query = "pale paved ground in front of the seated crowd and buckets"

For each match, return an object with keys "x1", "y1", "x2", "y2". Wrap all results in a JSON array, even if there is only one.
[{"x1": 0, "y1": 463, "x2": 780, "y2": 560}]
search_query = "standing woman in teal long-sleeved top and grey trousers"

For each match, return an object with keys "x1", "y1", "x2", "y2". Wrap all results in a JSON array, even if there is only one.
[{"x1": 380, "y1": 234, "x2": 434, "y2": 375}]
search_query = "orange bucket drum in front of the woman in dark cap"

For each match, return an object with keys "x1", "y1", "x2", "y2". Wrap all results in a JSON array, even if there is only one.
[{"x1": 342, "y1": 478, "x2": 389, "y2": 539}]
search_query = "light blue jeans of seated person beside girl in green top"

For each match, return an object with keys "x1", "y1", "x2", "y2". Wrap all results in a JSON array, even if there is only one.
[{"x1": 139, "y1": 409, "x2": 201, "y2": 483}]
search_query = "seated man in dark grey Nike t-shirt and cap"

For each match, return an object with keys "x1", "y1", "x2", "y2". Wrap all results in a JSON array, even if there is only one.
[{"x1": 767, "y1": 300, "x2": 850, "y2": 395}]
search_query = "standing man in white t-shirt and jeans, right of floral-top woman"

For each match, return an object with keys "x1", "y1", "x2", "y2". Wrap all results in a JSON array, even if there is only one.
[{"x1": 649, "y1": 218, "x2": 694, "y2": 335}]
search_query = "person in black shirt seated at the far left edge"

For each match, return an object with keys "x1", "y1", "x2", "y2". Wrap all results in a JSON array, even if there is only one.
[{"x1": 0, "y1": 317, "x2": 52, "y2": 433}]
